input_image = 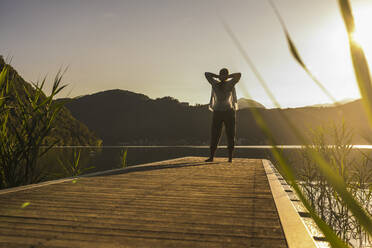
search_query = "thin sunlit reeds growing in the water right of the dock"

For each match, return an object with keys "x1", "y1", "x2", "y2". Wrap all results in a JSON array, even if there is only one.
[{"x1": 296, "y1": 123, "x2": 372, "y2": 247}]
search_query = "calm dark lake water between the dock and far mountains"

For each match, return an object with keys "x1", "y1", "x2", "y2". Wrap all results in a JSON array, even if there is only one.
[{"x1": 40, "y1": 145, "x2": 372, "y2": 176}]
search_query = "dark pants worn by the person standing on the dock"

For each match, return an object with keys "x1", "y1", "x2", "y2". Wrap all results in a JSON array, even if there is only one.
[{"x1": 210, "y1": 109, "x2": 235, "y2": 151}]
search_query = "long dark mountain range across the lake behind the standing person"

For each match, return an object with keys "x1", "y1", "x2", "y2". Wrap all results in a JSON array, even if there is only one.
[{"x1": 61, "y1": 89, "x2": 370, "y2": 145}]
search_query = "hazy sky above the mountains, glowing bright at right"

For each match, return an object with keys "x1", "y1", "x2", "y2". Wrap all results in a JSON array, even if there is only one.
[{"x1": 0, "y1": 0, "x2": 372, "y2": 108}]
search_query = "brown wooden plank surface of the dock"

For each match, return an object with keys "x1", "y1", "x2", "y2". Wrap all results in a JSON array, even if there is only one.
[{"x1": 0, "y1": 157, "x2": 287, "y2": 248}]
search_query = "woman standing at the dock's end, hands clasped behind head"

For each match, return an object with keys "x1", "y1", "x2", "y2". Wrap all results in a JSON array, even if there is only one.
[{"x1": 205, "y1": 68, "x2": 241, "y2": 162}]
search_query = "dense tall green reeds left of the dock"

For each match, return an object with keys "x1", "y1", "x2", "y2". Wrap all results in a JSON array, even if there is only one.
[{"x1": 0, "y1": 66, "x2": 66, "y2": 188}]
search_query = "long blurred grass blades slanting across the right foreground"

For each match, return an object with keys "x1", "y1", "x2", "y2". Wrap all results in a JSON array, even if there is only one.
[{"x1": 222, "y1": 0, "x2": 372, "y2": 247}]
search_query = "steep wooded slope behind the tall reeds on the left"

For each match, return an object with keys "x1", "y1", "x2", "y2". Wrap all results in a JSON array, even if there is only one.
[{"x1": 0, "y1": 56, "x2": 102, "y2": 145}]
